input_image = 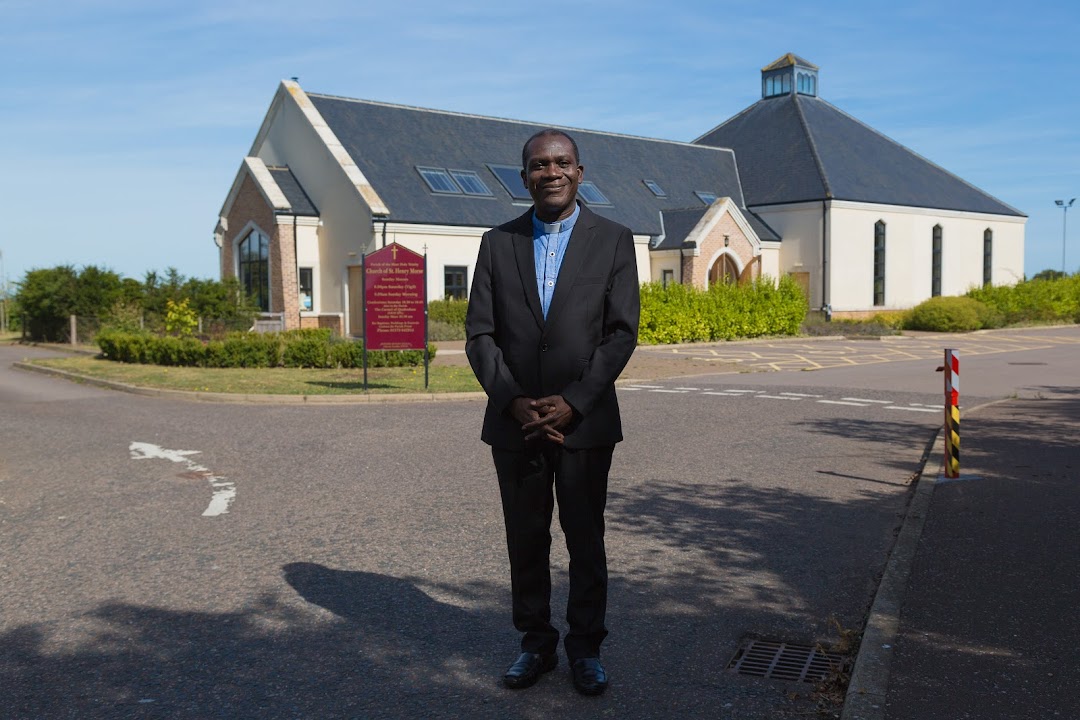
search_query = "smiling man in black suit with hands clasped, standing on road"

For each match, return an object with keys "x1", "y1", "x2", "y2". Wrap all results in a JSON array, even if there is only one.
[{"x1": 465, "y1": 130, "x2": 639, "y2": 695}]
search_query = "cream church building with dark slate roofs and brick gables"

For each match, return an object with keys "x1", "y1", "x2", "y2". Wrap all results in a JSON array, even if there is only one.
[{"x1": 214, "y1": 54, "x2": 1026, "y2": 336}]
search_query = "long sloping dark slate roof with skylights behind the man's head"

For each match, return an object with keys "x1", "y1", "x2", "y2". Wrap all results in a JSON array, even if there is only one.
[{"x1": 308, "y1": 93, "x2": 756, "y2": 235}]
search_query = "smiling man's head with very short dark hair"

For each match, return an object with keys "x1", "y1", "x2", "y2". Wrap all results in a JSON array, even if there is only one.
[{"x1": 522, "y1": 135, "x2": 585, "y2": 222}]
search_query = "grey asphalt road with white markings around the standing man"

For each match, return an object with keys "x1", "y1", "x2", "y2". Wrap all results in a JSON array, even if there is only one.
[{"x1": 0, "y1": 328, "x2": 1080, "y2": 718}]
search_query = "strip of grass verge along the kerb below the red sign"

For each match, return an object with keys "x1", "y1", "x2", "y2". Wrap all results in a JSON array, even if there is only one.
[{"x1": 30, "y1": 357, "x2": 482, "y2": 395}]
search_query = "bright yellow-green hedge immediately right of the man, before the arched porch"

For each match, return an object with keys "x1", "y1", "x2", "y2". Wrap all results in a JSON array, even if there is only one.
[{"x1": 638, "y1": 276, "x2": 809, "y2": 344}]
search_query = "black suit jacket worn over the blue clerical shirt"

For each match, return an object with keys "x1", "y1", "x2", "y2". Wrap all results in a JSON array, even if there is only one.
[{"x1": 465, "y1": 205, "x2": 640, "y2": 450}]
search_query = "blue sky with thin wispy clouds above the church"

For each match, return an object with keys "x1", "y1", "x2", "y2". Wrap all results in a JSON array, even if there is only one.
[{"x1": 0, "y1": 0, "x2": 1080, "y2": 282}]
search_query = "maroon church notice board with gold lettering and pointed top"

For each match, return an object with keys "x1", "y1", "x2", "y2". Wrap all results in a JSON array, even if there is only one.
[{"x1": 364, "y1": 243, "x2": 426, "y2": 350}]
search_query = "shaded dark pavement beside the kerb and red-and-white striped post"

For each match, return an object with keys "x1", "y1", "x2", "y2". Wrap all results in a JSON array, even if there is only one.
[{"x1": 842, "y1": 395, "x2": 1080, "y2": 720}]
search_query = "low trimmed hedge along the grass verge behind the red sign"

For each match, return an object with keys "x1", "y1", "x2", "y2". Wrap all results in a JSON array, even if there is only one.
[{"x1": 96, "y1": 328, "x2": 435, "y2": 368}]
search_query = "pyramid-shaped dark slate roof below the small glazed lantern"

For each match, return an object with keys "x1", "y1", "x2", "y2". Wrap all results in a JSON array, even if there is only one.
[{"x1": 694, "y1": 95, "x2": 1024, "y2": 217}]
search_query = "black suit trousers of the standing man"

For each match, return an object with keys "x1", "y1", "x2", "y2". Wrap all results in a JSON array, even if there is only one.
[{"x1": 491, "y1": 443, "x2": 615, "y2": 662}]
